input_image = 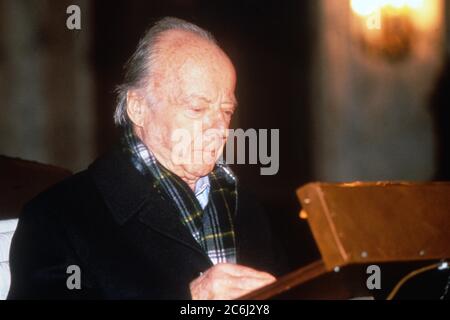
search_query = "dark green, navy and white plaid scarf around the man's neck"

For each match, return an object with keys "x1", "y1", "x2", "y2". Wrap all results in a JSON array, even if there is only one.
[{"x1": 122, "y1": 127, "x2": 237, "y2": 264}]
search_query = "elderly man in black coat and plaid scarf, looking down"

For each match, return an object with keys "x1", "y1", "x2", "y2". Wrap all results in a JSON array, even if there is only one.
[{"x1": 9, "y1": 18, "x2": 280, "y2": 299}]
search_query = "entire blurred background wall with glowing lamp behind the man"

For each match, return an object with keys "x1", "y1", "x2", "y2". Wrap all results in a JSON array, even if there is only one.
[{"x1": 0, "y1": 0, "x2": 450, "y2": 269}]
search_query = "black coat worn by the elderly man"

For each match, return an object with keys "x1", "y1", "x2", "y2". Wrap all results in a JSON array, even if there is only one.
[{"x1": 8, "y1": 148, "x2": 284, "y2": 299}]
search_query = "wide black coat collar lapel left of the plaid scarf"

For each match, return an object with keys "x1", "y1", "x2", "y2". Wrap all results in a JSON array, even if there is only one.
[{"x1": 88, "y1": 144, "x2": 209, "y2": 260}]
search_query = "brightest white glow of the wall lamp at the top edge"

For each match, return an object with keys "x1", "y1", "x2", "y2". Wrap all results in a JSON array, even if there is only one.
[{"x1": 351, "y1": 0, "x2": 425, "y2": 16}]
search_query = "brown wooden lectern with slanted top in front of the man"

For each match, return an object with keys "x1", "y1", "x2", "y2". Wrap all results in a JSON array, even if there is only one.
[{"x1": 242, "y1": 182, "x2": 450, "y2": 300}]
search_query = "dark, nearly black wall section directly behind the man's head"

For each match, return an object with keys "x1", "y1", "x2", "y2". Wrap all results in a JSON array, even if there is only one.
[{"x1": 93, "y1": 0, "x2": 317, "y2": 267}]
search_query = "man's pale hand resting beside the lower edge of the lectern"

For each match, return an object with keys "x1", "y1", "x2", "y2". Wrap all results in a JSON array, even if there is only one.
[{"x1": 190, "y1": 264, "x2": 276, "y2": 300}]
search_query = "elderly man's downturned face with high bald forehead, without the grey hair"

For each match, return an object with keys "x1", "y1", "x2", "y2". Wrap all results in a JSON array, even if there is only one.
[{"x1": 135, "y1": 33, "x2": 236, "y2": 179}]
